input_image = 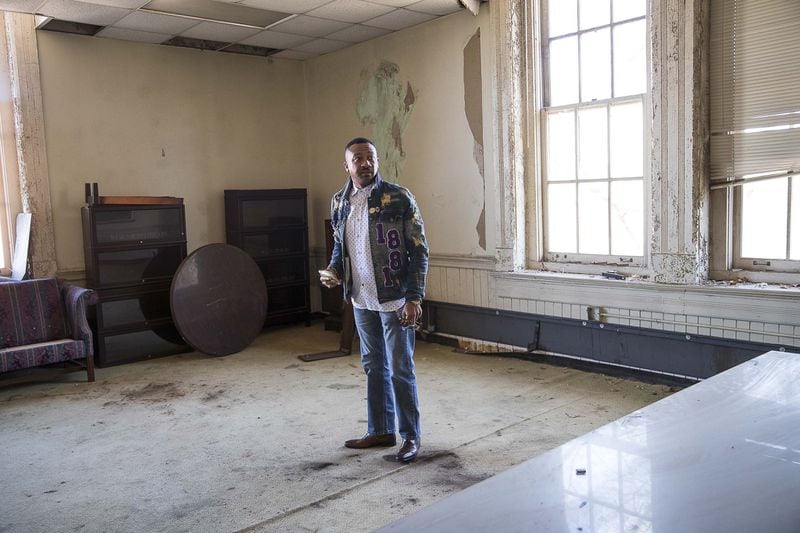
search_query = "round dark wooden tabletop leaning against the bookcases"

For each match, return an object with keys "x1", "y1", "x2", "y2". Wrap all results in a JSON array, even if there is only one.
[{"x1": 169, "y1": 244, "x2": 267, "y2": 355}]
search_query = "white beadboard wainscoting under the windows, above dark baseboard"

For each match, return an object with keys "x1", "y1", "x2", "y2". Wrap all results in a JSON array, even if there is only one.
[{"x1": 426, "y1": 255, "x2": 800, "y2": 347}]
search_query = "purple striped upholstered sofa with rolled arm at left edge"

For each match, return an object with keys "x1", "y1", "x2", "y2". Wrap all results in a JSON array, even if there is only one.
[{"x1": 0, "y1": 278, "x2": 97, "y2": 381}]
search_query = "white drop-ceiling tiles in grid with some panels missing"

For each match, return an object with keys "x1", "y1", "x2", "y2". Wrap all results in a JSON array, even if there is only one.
[{"x1": 0, "y1": 0, "x2": 461, "y2": 59}]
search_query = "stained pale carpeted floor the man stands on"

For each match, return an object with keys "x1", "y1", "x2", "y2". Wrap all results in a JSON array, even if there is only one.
[{"x1": 0, "y1": 324, "x2": 670, "y2": 532}]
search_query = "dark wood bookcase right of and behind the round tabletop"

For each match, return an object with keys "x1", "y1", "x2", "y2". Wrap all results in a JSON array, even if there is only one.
[{"x1": 225, "y1": 189, "x2": 311, "y2": 325}]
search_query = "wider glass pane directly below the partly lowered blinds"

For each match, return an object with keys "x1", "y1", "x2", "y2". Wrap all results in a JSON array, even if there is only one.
[{"x1": 741, "y1": 178, "x2": 789, "y2": 259}]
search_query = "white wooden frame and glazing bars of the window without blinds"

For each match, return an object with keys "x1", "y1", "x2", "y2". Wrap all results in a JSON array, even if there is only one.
[{"x1": 526, "y1": 0, "x2": 652, "y2": 274}]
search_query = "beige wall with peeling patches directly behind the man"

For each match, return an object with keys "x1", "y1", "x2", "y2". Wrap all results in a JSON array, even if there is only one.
[{"x1": 305, "y1": 10, "x2": 494, "y2": 255}]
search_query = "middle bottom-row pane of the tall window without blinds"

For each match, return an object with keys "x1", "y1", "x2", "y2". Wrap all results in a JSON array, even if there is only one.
[{"x1": 578, "y1": 181, "x2": 608, "y2": 254}]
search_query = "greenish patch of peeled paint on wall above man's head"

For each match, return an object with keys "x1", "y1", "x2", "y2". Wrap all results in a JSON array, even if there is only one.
[{"x1": 356, "y1": 61, "x2": 417, "y2": 183}]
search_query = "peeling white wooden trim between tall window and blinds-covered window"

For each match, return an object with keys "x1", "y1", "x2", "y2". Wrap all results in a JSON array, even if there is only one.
[{"x1": 650, "y1": 0, "x2": 710, "y2": 284}]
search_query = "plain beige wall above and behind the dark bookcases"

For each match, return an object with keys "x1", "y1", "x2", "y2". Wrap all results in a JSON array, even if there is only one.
[{"x1": 37, "y1": 32, "x2": 308, "y2": 272}]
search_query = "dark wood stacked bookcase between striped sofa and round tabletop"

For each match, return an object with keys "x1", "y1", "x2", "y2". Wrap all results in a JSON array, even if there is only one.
[{"x1": 81, "y1": 204, "x2": 188, "y2": 367}]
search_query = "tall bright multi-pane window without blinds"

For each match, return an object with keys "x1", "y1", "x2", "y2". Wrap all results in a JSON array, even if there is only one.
[{"x1": 541, "y1": 0, "x2": 647, "y2": 264}]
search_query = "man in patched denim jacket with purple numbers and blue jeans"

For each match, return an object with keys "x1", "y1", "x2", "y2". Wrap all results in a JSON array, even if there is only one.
[{"x1": 320, "y1": 137, "x2": 428, "y2": 462}]
